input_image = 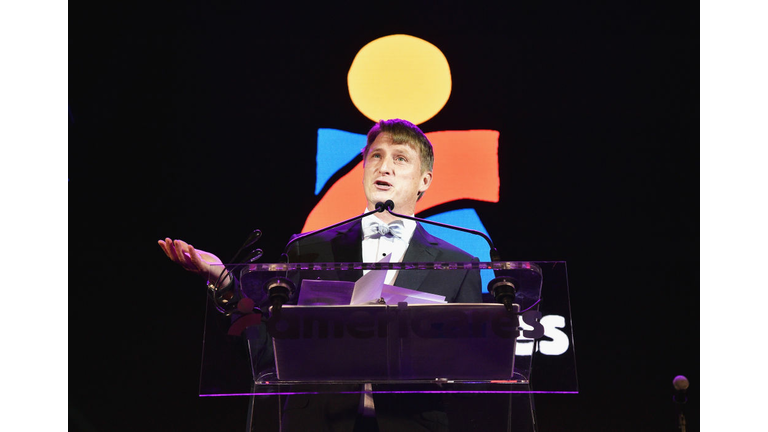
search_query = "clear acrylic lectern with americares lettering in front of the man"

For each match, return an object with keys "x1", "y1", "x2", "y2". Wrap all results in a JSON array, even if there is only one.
[{"x1": 200, "y1": 261, "x2": 578, "y2": 432}]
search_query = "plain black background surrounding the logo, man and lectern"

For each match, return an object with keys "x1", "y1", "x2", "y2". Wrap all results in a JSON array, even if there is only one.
[{"x1": 69, "y1": 0, "x2": 699, "y2": 432}]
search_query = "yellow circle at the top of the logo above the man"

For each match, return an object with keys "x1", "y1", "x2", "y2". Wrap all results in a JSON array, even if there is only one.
[{"x1": 347, "y1": 34, "x2": 451, "y2": 124}]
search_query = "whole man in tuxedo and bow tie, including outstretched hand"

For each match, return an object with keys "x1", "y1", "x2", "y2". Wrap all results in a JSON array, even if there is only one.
[{"x1": 158, "y1": 119, "x2": 482, "y2": 432}]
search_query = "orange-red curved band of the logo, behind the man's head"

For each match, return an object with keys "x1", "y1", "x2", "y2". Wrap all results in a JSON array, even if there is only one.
[{"x1": 302, "y1": 130, "x2": 499, "y2": 232}]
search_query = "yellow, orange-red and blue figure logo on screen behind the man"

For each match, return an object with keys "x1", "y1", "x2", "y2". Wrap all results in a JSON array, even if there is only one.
[{"x1": 302, "y1": 35, "x2": 499, "y2": 289}]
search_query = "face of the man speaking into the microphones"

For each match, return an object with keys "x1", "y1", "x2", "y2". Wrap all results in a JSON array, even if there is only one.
[{"x1": 363, "y1": 133, "x2": 432, "y2": 215}]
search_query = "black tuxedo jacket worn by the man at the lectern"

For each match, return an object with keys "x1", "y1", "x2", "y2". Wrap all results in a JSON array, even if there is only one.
[{"x1": 286, "y1": 220, "x2": 483, "y2": 303}]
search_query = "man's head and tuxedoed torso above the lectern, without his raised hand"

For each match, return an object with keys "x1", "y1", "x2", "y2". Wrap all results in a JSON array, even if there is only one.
[{"x1": 286, "y1": 119, "x2": 482, "y2": 303}]
